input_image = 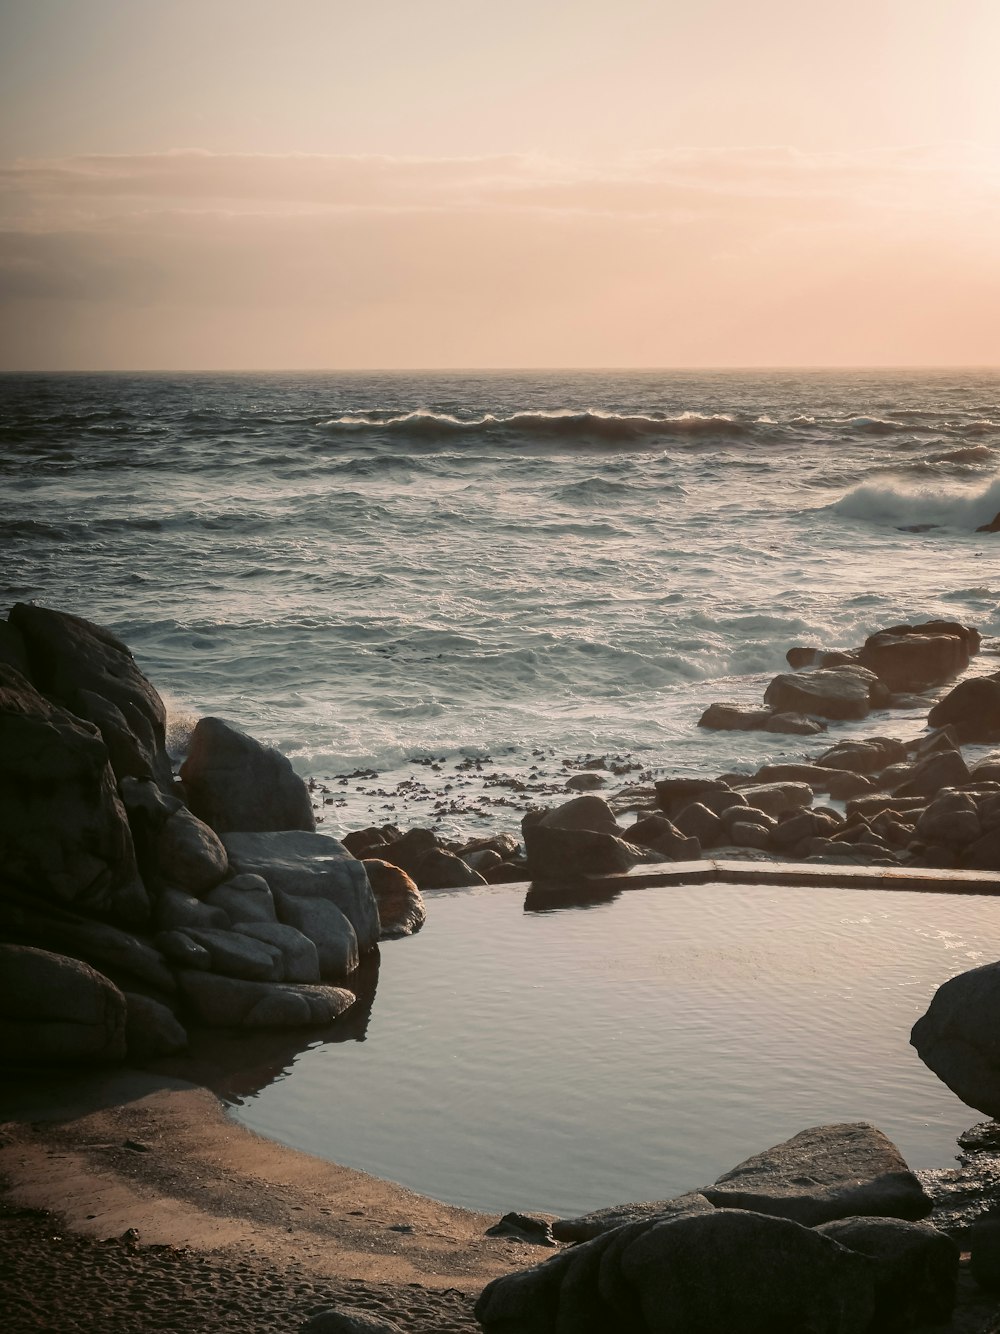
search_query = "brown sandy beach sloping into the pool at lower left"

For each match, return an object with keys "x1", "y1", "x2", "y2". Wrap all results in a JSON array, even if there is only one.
[{"x1": 0, "y1": 1073, "x2": 548, "y2": 1334}]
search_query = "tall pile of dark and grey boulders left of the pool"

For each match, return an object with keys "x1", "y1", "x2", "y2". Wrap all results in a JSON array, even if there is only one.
[{"x1": 0, "y1": 603, "x2": 386, "y2": 1062}]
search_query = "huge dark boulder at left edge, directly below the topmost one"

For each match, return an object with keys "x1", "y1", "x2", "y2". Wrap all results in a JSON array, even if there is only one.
[{"x1": 0, "y1": 666, "x2": 149, "y2": 922}]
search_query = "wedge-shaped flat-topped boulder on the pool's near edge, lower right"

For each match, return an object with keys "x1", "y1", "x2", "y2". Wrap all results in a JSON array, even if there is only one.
[{"x1": 701, "y1": 1122, "x2": 932, "y2": 1227}]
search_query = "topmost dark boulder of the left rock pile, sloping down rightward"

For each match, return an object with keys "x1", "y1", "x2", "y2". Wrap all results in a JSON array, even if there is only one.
[{"x1": 9, "y1": 602, "x2": 173, "y2": 791}]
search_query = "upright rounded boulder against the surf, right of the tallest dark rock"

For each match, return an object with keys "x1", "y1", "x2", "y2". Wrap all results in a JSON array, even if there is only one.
[{"x1": 180, "y1": 718, "x2": 316, "y2": 834}]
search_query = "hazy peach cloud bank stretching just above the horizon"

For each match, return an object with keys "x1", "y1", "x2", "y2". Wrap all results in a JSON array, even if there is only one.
[{"x1": 0, "y1": 148, "x2": 1000, "y2": 366}]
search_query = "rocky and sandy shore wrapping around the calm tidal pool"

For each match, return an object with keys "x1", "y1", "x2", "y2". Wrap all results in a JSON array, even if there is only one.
[{"x1": 0, "y1": 604, "x2": 1000, "y2": 1334}]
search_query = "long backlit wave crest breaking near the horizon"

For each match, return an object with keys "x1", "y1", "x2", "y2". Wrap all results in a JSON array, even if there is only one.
[{"x1": 317, "y1": 410, "x2": 755, "y2": 443}]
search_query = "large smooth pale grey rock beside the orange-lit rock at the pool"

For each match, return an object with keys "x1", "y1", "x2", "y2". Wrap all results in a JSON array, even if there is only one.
[{"x1": 223, "y1": 831, "x2": 380, "y2": 955}]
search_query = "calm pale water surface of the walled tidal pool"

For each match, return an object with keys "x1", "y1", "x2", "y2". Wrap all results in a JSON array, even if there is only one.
[{"x1": 235, "y1": 884, "x2": 1000, "y2": 1215}]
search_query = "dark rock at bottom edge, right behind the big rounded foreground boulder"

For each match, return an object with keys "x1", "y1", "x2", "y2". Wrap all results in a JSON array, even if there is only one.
[{"x1": 816, "y1": 1218, "x2": 960, "y2": 1334}]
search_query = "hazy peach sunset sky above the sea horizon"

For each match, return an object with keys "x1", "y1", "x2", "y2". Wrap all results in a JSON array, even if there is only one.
[{"x1": 0, "y1": 0, "x2": 1000, "y2": 370}]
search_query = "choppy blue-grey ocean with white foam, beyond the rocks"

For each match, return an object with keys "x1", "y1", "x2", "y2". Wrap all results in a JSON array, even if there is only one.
[{"x1": 0, "y1": 371, "x2": 1000, "y2": 836}]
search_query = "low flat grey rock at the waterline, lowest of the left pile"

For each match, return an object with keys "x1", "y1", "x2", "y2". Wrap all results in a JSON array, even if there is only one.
[{"x1": 177, "y1": 970, "x2": 355, "y2": 1029}]
